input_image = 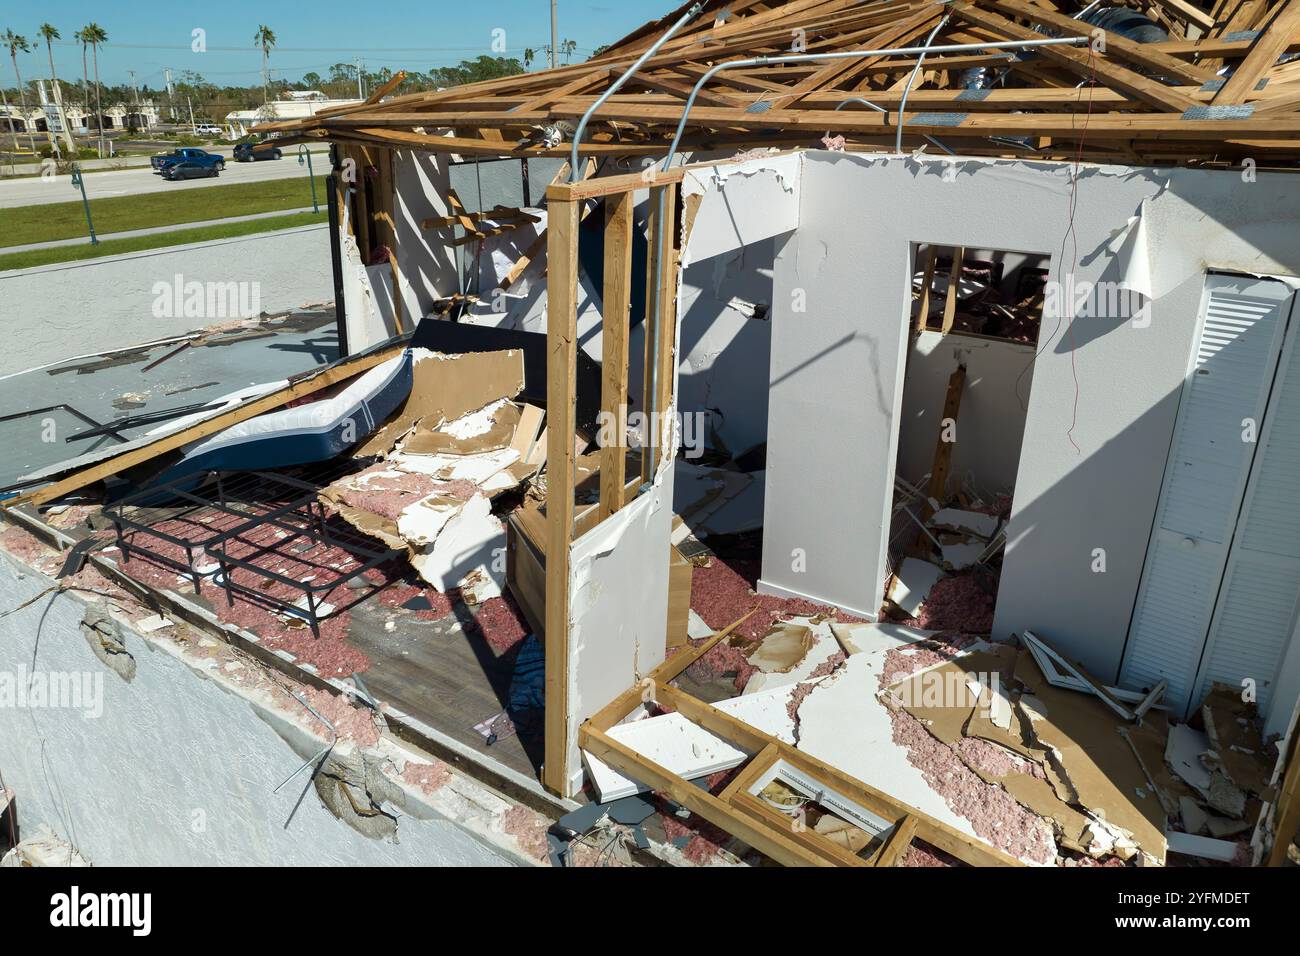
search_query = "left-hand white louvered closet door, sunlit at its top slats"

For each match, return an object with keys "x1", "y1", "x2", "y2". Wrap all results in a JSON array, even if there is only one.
[{"x1": 1119, "y1": 276, "x2": 1291, "y2": 713}]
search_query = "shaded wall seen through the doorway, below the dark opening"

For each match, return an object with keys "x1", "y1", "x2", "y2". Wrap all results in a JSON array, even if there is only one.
[{"x1": 898, "y1": 332, "x2": 1034, "y2": 496}]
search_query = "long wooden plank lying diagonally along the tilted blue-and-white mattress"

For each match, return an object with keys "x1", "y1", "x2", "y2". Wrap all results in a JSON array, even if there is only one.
[{"x1": 0, "y1": 343, "x2": 406, "y2": 509}]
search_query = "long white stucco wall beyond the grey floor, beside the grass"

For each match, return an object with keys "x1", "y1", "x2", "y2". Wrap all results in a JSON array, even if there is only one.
[{"x1": 0, "y1": 225, "x2": 334, "y2": 375}]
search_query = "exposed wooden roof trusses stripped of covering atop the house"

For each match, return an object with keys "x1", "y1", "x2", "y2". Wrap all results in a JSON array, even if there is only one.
[{"x1": 263, "y1": 0, "x2": 1300, "y2": 163}]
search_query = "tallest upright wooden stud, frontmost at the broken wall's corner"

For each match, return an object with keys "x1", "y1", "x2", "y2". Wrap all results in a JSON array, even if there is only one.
[{"x1": 542, "y1": 187, "x2": 579, "y2": 796}]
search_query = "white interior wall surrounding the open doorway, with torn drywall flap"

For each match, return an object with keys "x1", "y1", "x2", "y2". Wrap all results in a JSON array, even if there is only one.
[{"x1": 763, "y1": 152, "x2": 1300, "y2": 680}]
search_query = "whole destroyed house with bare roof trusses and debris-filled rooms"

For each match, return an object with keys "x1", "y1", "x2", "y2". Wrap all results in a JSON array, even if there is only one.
[{"x1": 0, "y1": 0, "x2": 1300, "y2": 865}]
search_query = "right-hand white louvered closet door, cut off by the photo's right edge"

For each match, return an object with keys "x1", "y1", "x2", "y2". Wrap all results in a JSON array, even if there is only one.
[{"x1": 1192, "y1": 304, "x2": 1300, "y2": 713}]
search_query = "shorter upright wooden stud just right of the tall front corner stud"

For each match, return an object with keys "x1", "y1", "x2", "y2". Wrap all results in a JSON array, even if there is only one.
[{"x1": 601, "y1": 193, "x2": 634, "y2": 520}]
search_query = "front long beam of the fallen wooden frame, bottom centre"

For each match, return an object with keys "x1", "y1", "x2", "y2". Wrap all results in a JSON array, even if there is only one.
[{"x1": 579, "y1": 723, "x2": 831, "y2": 866}]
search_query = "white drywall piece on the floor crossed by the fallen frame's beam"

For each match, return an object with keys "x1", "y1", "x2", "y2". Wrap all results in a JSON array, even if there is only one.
[{"x1": 582, "y1": 713, "x2": 749, "y2": 804}]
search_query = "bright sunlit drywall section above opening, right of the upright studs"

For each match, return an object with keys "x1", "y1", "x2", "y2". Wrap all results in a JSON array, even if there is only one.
[{"x1": 681, "y1": 153, "x2": 802, "y2": 265}]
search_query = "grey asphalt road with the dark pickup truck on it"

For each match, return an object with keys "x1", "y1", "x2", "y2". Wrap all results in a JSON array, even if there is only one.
[{"x1": 0, "y1": 152, "x2": 329, "y2": 209}]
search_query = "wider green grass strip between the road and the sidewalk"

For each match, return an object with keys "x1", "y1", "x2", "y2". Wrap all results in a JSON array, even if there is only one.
[{"x1": 0, "y1": 171, "x2": 325, "y2": 248}]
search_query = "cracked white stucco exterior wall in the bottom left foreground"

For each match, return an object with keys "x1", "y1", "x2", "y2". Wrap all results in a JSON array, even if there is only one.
[{"x1": 0, "y1": 553, "x2": 521, "y2": 866}]
